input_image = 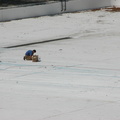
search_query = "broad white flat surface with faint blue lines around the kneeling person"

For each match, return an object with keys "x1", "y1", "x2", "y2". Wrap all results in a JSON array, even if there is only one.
[{"x1": 0, "y1": 10, "x2": 120, "y2": 120}]
